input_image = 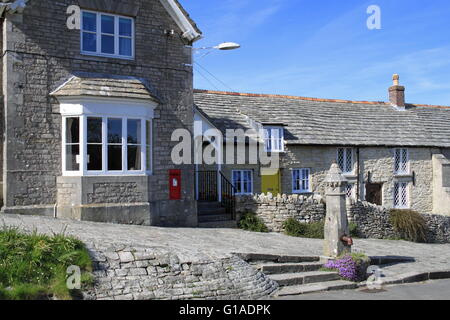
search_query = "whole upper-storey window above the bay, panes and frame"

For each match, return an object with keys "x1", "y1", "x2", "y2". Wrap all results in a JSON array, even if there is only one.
[{"x1": 81, "y1": 11, "x2": 134, "y2": 59}]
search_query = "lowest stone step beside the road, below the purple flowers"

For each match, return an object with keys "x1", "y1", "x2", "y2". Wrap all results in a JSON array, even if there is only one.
[{"x1": 275, "y1": 280, "x2": 358, "y2": 297}]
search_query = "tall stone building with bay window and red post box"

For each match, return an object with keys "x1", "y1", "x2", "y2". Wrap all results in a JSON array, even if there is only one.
[{"x1": 0, "y1": 0, "x2": 201, "y2": 226}]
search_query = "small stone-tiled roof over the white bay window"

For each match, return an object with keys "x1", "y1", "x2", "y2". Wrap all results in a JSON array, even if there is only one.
[{"x1": 51, "y1": 73, "x2": 160, "y2": 101}]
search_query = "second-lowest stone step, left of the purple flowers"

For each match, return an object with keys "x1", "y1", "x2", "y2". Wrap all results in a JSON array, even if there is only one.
[{"x1": 269, "y1": 271, "x2": 340, "y2": 287}]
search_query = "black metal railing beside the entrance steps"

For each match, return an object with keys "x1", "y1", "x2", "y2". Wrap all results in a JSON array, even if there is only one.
[{"x1": 196, "y1": 171, "x2": 236, "y2": 220}]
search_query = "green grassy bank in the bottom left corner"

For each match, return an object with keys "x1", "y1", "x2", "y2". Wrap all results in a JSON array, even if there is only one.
[{"x1": 0, "y1": 228, "x2": 92, "y2": 300}]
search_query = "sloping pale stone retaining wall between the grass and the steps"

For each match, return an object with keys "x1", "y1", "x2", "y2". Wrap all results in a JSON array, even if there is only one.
[{"x1": 84, "y1": 247, "x2": 278, "y2": 300}]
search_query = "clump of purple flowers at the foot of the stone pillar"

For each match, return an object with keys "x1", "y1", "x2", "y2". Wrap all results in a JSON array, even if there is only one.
[{"x1": 323, "y1": 253, "x2": 370, "y2": 282}]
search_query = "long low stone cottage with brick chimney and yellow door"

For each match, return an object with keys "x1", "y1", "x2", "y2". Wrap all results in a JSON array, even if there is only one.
[{"x1": 194, "y1": 75, "x2": 450, "y2": 215}]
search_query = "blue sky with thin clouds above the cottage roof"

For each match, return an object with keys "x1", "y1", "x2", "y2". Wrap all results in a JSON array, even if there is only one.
[{"x1": 180, "y1": 0, "x2": 450, "y2": 105}]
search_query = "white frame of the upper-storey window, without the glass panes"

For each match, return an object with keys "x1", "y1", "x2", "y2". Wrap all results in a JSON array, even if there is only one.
[{"x1": 80, "y1": 10, "x2": 136, "y2": 60}]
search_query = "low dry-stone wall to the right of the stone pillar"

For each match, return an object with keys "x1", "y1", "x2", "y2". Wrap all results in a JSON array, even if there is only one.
[{"x1": 347, "y1": 201, "x2": 450, "y2": 243}]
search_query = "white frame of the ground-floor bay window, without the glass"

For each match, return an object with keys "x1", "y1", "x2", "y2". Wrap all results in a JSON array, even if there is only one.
[{"x1": 60, "y1": 97, "x2": 156, "y2": 176}]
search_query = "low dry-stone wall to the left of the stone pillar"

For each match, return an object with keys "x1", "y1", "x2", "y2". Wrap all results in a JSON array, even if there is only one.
[{"x1": 236, "y1": 193, "x2": 326, "y2": 232}]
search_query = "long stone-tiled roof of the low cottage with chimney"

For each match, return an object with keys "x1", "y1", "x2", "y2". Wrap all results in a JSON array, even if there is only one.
[{"x1": 194, "y1": 90, "x2": 450, "y2": 147}]
